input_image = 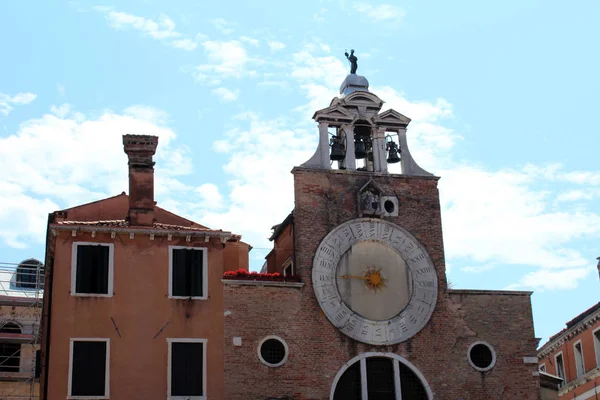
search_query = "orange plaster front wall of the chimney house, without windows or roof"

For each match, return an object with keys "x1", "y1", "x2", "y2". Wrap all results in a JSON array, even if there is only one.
[{"x1": 47, "y1": 232, "x2": 230, "y2": 400}]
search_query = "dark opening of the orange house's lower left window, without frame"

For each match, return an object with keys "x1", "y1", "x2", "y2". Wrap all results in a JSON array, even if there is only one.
[{"x1": 71, "y1": 341, "x2": 107, "y2": 396}]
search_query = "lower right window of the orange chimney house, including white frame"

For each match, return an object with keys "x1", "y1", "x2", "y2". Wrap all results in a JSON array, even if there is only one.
[{"x1": 167, "y1": 339, "x2": 206, "y2": 400}]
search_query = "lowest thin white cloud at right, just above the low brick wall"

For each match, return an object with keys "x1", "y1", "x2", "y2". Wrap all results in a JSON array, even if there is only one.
[{"x1": 506, "y1": 268, "x2": 594, "y2": 291}]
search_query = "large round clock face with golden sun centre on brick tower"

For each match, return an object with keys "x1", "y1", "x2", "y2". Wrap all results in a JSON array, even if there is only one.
[{"x1": 312, "y1": 218, "x2": 437, "y2": 345}]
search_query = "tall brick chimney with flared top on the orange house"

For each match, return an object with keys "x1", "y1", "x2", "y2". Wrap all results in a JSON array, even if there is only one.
[{"x1": 123, "y1": 135, "x2": 158, "y2": 226}]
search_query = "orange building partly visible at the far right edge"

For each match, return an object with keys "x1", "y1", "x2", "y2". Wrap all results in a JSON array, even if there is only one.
[{"x1": 538, "y1": 303, "x2": 600, "y2": 400}]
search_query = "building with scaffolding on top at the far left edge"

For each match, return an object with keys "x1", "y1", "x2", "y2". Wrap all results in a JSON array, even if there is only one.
[{"x1": 0, "y1": 258, "x2": 44, "y2": 400}]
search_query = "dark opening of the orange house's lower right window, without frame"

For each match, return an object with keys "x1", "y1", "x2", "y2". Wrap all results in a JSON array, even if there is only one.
[{"x1": 171, "y1": 342, "x2": 204, "y2": 396}]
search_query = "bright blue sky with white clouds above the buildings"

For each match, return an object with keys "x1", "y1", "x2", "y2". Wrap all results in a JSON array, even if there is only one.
[{"x1": 0, "y1": 0, "x2": 600, "y2": 341}]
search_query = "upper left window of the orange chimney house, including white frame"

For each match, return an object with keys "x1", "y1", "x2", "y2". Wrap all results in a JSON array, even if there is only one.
[{"x1": 71, "y1": 242, "x2": 113, "y2": 297}]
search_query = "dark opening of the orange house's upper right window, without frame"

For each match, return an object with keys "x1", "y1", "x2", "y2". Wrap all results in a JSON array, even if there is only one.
[{"x1": 172, "y1": 249, "x2": 204, "y2": 297}]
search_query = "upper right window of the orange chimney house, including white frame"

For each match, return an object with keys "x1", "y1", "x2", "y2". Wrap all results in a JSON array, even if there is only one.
[{"x1": 169, "y1": 246, "x2": 208, "y2": 299}]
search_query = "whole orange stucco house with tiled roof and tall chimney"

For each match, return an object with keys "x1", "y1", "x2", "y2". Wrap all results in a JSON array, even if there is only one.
[{"x1": 41, "y1": 135, "x2": 249, "y2": 400}]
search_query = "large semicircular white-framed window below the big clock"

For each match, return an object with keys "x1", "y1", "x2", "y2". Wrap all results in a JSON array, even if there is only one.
[{"x1": 331, "y1": 353, "x2": 433, "y2": 400}]
